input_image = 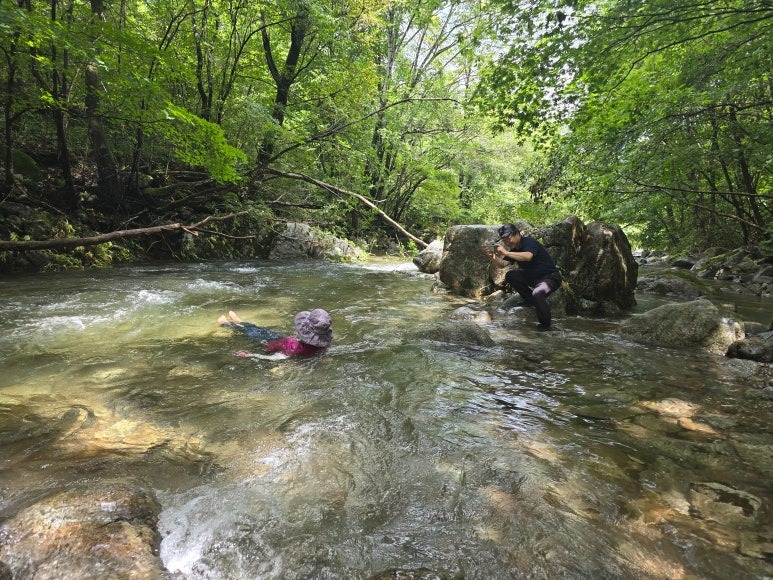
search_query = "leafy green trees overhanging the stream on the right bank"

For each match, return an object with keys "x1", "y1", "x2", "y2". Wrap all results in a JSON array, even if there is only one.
[{"x1": 481, "y1": 0, "x2": 773, "y2": 247}]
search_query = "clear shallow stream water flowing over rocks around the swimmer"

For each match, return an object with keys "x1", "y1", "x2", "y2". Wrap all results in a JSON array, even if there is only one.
[{"x1": 0, "y1": 261, "x2": 773, "y2": 580}]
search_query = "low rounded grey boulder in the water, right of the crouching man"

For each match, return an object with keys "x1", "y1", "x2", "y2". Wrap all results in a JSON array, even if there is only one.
[{"x1": 619, "y1": 298, "x2": 743, "y2": 354}]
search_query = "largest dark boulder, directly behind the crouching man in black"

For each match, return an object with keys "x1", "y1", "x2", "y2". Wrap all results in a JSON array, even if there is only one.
[{"x1": 440, "y1": 216, "x2": 639, "y2": 314}]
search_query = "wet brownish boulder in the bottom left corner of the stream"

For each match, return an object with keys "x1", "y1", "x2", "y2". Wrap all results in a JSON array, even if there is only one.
[{"x1": 0, "y1": 481, "x2": 168, "y2": 580}]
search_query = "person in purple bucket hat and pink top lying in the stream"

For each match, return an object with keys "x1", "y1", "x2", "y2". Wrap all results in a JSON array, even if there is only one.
[{"x1": 217, "y1": 308, "x2": 333, "y2": 358}]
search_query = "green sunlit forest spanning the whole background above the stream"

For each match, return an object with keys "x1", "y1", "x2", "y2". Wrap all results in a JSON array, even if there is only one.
[{"x1": 0, "y1": 0, "x2": 773, "y2": 260}]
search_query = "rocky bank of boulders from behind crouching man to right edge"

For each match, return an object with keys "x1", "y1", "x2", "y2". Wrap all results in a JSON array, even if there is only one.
[{"x1": 414, "y1": 216, "x2": 773, "y2": 364}]
